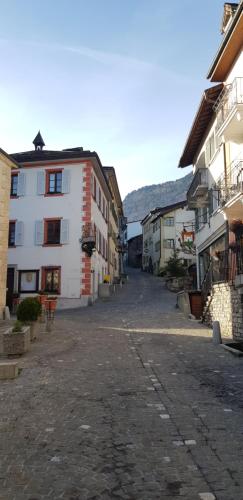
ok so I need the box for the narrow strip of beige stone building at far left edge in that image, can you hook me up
[0,158,11,318]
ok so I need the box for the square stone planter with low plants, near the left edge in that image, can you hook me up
[3,321,30,356]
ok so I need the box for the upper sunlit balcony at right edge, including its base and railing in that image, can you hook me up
[214,78,243,140]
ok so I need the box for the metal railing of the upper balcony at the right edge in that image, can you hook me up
[214,77,243,132]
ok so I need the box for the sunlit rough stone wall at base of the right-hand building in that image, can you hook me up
[205,283,243,340]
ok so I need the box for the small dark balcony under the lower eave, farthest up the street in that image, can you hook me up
[187,168,208,209]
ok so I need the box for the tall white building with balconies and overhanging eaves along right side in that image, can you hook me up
[179,1,243,337]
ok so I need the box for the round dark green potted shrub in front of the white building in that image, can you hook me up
[17,297,41,340]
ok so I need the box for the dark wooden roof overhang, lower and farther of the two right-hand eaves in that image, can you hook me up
[178,83,223,168]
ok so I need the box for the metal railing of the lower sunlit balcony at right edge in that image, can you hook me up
[217,159,243,206]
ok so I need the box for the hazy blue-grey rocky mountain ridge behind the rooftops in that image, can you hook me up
[123,172,192,222]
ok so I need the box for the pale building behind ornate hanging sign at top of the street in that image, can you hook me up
[142,201,195,275]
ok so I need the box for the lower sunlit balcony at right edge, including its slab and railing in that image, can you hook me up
[217,159,243,221]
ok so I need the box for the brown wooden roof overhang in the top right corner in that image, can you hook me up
[207,0,243,82]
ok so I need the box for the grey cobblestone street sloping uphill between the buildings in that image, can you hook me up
[0,272,243,500]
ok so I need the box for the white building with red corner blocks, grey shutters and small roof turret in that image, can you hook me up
[8,134,111,307]
